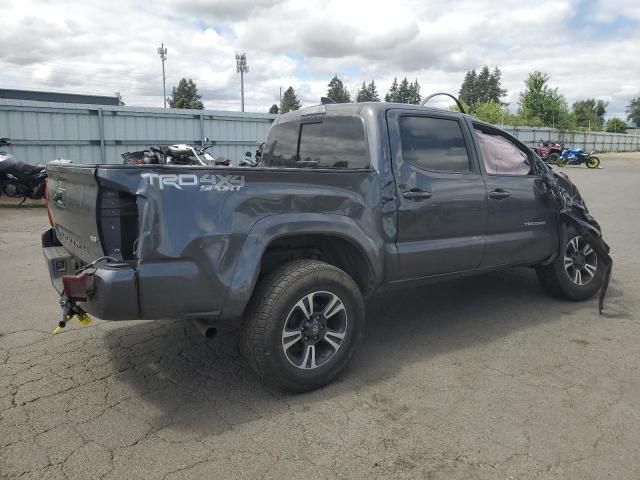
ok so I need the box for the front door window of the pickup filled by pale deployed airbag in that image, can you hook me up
[474,128,531,175]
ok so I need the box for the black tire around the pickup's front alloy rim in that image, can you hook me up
[536,226,605,301]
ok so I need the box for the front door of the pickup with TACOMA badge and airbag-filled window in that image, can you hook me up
[473,123,558,267]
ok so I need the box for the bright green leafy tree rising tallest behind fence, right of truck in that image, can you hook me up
[518,71,575,130]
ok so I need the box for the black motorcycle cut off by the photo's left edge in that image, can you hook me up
[0,138,47,205]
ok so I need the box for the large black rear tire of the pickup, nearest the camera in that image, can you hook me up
[240,260,364,392]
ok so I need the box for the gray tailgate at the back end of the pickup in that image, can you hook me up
[47,164,104,262]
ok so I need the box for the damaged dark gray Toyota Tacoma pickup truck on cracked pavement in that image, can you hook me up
[42,103,609,391]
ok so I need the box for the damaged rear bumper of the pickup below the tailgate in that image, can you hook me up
[42,229,140,320]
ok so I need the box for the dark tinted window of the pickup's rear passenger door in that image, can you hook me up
[399,116,471,173]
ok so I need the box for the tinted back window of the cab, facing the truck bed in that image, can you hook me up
[263,117,369,169]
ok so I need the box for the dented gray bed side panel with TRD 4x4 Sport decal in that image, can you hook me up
[99,166,384,319]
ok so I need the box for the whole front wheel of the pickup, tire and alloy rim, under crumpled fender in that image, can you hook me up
[536,227,604,300]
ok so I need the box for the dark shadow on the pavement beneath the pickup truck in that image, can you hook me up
[102,269,596,438]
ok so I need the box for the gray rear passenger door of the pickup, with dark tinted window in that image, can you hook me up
[387,110,487,281]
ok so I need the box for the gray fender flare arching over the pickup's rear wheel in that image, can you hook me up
[223,213,384,318]
